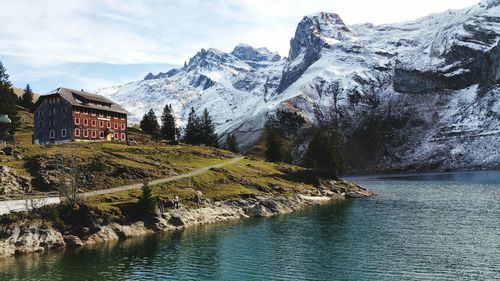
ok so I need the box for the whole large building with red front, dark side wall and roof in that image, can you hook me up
[33,88,128,144]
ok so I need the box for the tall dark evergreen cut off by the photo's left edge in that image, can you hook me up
[0,61,19,134]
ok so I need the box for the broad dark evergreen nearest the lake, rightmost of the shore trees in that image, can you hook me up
[304,128,345,178]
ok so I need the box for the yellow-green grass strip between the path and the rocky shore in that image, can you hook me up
[87,156,314,213]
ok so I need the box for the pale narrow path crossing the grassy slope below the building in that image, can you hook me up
[0,156,244,215]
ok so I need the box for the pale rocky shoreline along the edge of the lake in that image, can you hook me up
[0,180,374,257]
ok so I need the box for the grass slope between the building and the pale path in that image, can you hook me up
[0,111,235,190]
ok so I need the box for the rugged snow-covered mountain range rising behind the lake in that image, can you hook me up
[98,0,500,171]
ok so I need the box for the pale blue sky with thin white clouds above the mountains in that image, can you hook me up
[0,0,479,93]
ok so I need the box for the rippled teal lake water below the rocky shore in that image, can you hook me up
[0,172,500,280]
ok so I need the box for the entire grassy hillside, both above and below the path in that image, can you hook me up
[0,108,318,202]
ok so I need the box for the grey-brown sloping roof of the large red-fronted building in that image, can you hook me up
[34,87,129,114]
